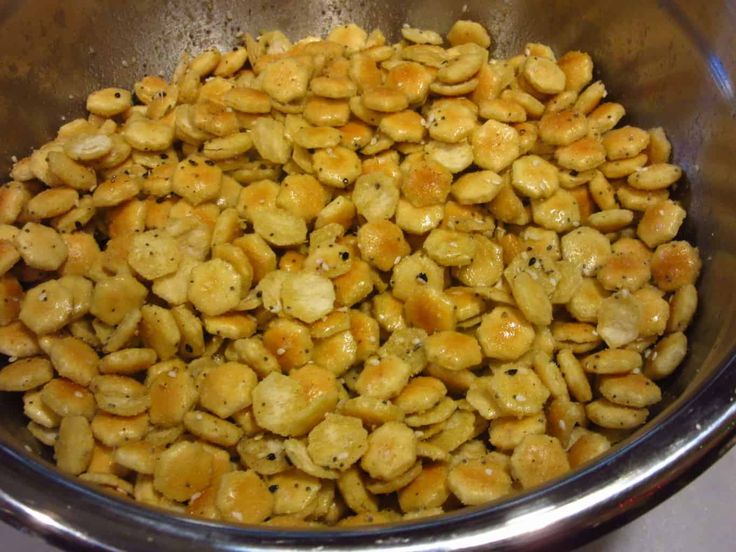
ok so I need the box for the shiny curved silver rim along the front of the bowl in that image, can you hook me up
[0,352,736,551]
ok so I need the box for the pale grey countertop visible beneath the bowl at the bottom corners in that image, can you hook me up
[0,448,736,552]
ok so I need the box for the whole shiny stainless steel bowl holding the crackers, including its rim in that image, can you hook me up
[0,0,736,551]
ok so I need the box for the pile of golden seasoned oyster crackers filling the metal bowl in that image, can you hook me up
[0,17,701,527]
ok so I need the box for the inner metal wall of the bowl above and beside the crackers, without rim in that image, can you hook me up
[0,0,736,532]
